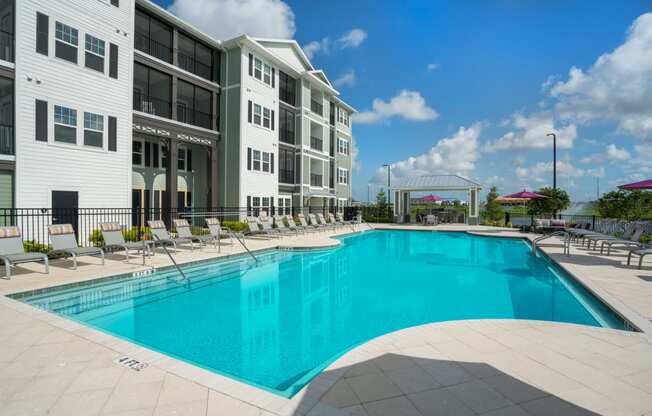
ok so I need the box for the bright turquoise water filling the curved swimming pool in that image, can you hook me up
[15,231,625,396]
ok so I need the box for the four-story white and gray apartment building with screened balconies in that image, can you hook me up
[0,0,355,219]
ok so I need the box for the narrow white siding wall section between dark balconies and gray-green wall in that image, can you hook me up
[240,48,279,207]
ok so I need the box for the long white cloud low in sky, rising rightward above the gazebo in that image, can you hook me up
[372,123,482,183]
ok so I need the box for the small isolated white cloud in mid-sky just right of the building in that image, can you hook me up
[354,90,439,124]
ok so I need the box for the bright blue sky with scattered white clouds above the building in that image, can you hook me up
[155,0,652,201]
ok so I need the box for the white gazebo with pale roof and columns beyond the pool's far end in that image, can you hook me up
[390,175,482,225]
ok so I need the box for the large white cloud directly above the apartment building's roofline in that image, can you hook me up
[168,0,296,40]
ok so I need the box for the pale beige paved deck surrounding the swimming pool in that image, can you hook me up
[0,224,652,416]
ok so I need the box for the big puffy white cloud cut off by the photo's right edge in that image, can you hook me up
[550,13,652,141]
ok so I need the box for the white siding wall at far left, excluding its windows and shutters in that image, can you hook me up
[16,0,134,208]
